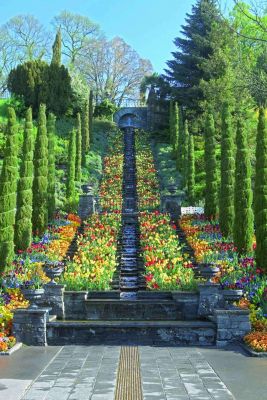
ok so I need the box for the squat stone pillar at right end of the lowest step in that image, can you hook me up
[217,307,251,347]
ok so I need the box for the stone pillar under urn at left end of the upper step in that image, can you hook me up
[44,283,65,319]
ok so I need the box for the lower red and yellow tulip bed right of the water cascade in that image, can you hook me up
[139,211,196,290]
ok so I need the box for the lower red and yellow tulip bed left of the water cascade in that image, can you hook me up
[61,212,121,291]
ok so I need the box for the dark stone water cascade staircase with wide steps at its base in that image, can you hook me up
[47,128,216,345]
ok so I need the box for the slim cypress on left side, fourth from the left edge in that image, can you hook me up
[47,113,56,221]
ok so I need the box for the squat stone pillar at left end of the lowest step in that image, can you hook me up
[13,308,50,346]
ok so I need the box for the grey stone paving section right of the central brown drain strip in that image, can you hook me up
[139,347,234,400]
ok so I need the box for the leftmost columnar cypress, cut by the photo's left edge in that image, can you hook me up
[0,108,18,271]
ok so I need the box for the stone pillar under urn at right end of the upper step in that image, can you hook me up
[198,282,223,317]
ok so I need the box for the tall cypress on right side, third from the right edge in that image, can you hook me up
[219,103,235,237]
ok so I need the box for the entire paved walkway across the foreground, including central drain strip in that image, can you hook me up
[0,346,267,400]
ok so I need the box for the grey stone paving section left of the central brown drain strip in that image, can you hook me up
[22,346,120,400]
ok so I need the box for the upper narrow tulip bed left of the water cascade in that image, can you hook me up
[99,133,123,211]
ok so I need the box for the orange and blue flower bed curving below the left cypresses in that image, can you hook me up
[0,214,80,351]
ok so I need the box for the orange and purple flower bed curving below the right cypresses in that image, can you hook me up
[180,215,267,351]
